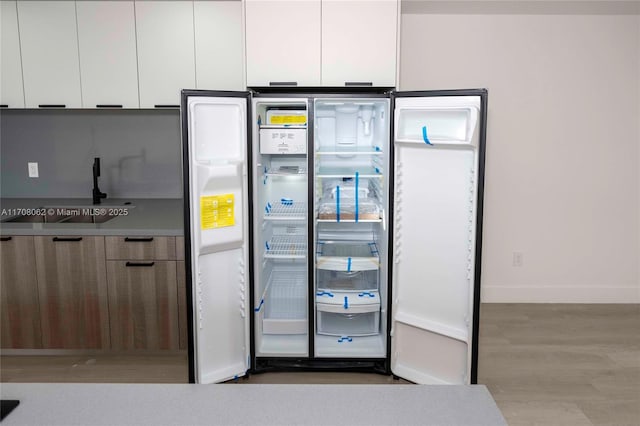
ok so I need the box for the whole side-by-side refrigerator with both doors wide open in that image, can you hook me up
[181,88,487,384]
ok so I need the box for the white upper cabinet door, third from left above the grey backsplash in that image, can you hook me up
[76,0,139,108]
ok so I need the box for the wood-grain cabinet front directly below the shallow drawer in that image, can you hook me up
[107,260,179,350]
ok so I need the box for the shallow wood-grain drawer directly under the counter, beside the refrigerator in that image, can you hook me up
[105,236,176,260]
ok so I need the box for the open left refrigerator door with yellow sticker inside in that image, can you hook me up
[182,91,250,383]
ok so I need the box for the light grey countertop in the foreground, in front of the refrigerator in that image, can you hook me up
[1,383,506,426]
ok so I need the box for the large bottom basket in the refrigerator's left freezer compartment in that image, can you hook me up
[257,266,308,334]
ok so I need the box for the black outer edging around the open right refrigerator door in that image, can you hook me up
[387,89,488,384]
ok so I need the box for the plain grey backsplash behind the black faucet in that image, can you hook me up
[0,110,182,198]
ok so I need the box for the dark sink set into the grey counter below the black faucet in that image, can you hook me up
[2,205,135,223]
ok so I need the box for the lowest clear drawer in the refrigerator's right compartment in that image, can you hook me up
[317,309,380,336]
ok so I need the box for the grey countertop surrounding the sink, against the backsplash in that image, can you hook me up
[0,198,184,236]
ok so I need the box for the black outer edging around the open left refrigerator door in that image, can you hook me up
[180,89,255,383]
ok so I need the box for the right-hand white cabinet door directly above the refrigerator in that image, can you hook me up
[322,0,398,87]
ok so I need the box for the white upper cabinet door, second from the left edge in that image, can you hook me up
[18,1,82,108]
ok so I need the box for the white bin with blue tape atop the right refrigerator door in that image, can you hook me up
[396,107,478,144]
